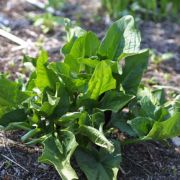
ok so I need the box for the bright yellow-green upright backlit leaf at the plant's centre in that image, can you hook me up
[86,61,116,99]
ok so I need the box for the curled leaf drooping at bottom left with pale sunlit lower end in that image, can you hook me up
[39,130,78,180]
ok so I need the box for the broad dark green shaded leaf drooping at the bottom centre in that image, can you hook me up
[75,142,121,180]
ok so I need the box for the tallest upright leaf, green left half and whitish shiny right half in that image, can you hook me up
[98,15,141,61]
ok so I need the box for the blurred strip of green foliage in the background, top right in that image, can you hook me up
[101,0,180,20]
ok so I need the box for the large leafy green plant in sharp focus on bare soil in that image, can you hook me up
[0,16,180,180]
